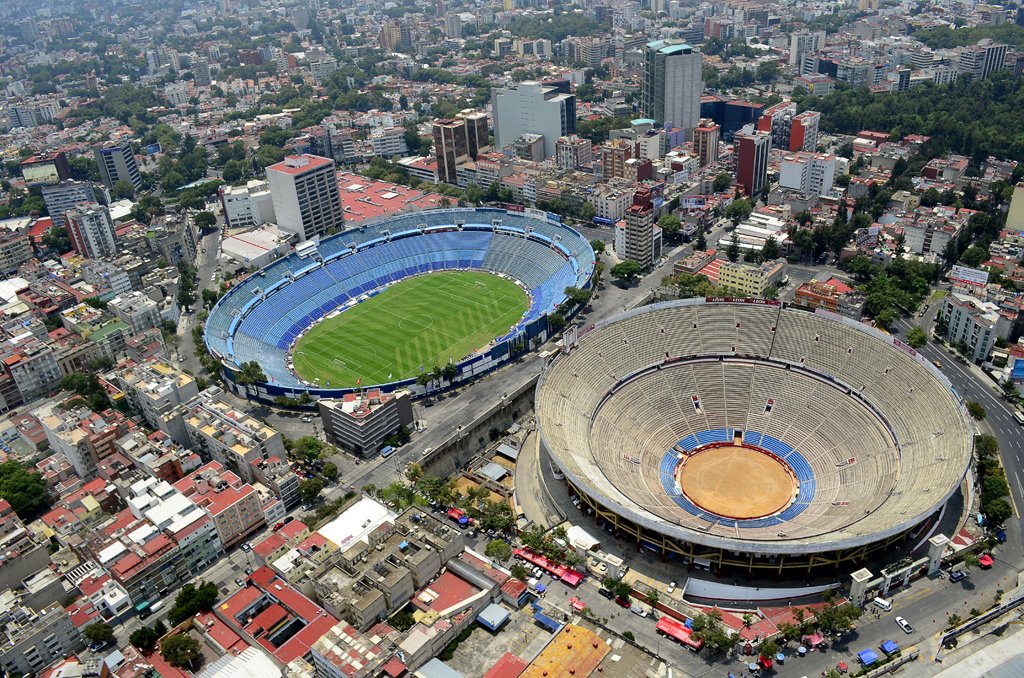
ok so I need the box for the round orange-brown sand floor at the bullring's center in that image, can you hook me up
[676,443,798,520]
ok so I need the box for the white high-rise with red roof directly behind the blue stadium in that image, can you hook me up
[266,155,345,242]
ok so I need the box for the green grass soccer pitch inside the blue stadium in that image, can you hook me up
[292,271,529,388]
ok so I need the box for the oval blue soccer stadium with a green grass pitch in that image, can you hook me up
[205,209,594,399]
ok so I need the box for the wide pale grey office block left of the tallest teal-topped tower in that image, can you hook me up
[490,80,575,158]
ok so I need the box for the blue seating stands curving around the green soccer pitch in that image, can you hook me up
[206,209,594,386]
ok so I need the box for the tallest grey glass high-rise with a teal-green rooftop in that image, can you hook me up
[643,40,703,138]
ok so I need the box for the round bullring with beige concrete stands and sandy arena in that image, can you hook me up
[536,299,973,573]
